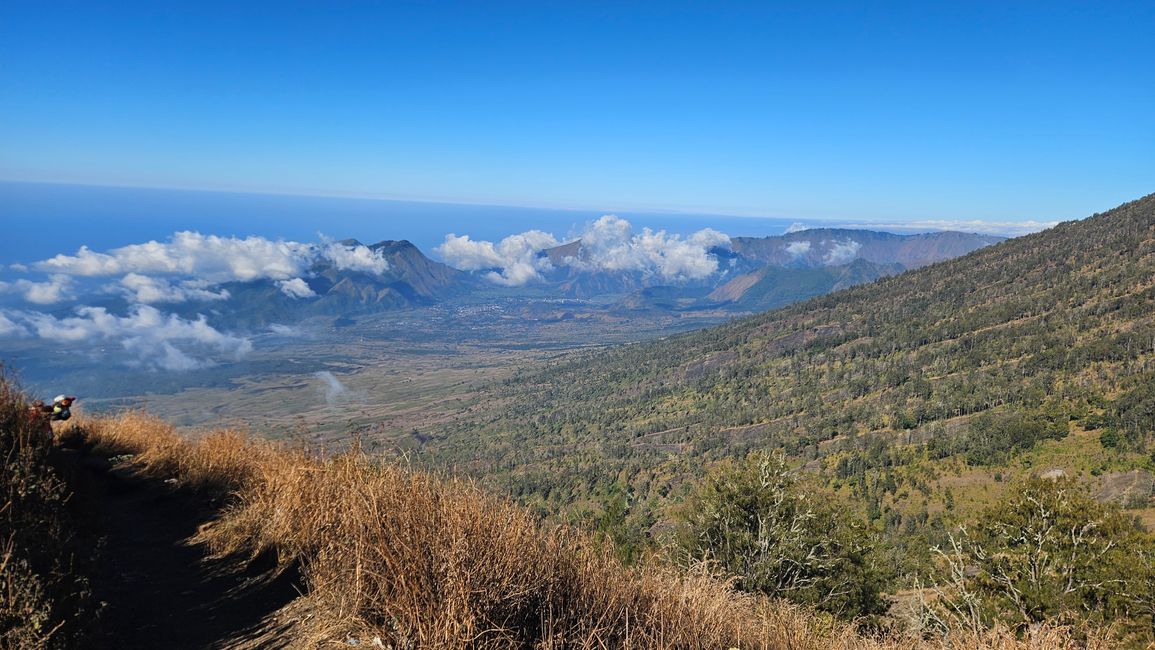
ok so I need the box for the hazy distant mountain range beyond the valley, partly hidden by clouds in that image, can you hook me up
[174,229,1001,327]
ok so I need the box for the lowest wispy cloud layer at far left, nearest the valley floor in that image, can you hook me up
[0,305,252,371]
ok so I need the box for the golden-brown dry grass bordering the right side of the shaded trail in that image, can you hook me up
[76,414,1106,650]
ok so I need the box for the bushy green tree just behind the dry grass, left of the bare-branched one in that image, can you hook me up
[681,451,886,618]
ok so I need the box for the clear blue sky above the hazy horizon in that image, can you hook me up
[0,0,1155,221]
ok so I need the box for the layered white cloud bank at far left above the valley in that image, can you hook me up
[0,231,389,371]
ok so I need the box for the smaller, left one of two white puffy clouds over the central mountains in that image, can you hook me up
[434,230,559,286]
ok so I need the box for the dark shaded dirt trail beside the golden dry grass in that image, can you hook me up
[60,450,298,650]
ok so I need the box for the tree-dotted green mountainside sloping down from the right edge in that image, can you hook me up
[422,195,1155,571]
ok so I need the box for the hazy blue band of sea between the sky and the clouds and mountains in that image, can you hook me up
[0,181,1057,266]
